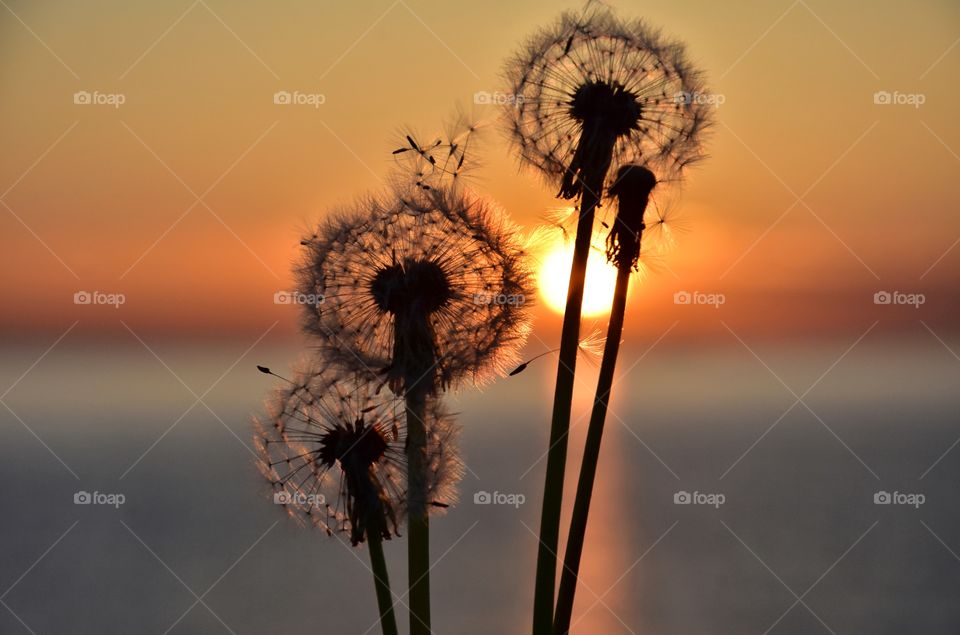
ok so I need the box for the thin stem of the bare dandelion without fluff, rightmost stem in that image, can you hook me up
[553,262,631,635]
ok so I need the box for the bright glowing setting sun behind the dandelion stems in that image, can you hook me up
[537,240,617,317]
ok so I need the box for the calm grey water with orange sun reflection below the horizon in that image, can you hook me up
[0,336,960,635]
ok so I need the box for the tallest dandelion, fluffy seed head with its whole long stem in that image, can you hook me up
[506,4,710,633]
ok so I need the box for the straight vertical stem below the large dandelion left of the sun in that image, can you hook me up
[406,389,431,635]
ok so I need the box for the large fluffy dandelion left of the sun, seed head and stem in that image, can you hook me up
[299,181,532,635]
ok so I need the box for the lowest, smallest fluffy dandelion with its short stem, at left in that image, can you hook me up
[254,367,462,633]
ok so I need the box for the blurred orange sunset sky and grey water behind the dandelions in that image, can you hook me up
[0,0,960,635]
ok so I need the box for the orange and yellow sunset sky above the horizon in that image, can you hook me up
[0,0,960,339]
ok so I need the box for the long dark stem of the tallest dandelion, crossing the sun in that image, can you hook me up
[533,181,603,635]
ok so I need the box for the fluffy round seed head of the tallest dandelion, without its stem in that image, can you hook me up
[506,3,711,198]
